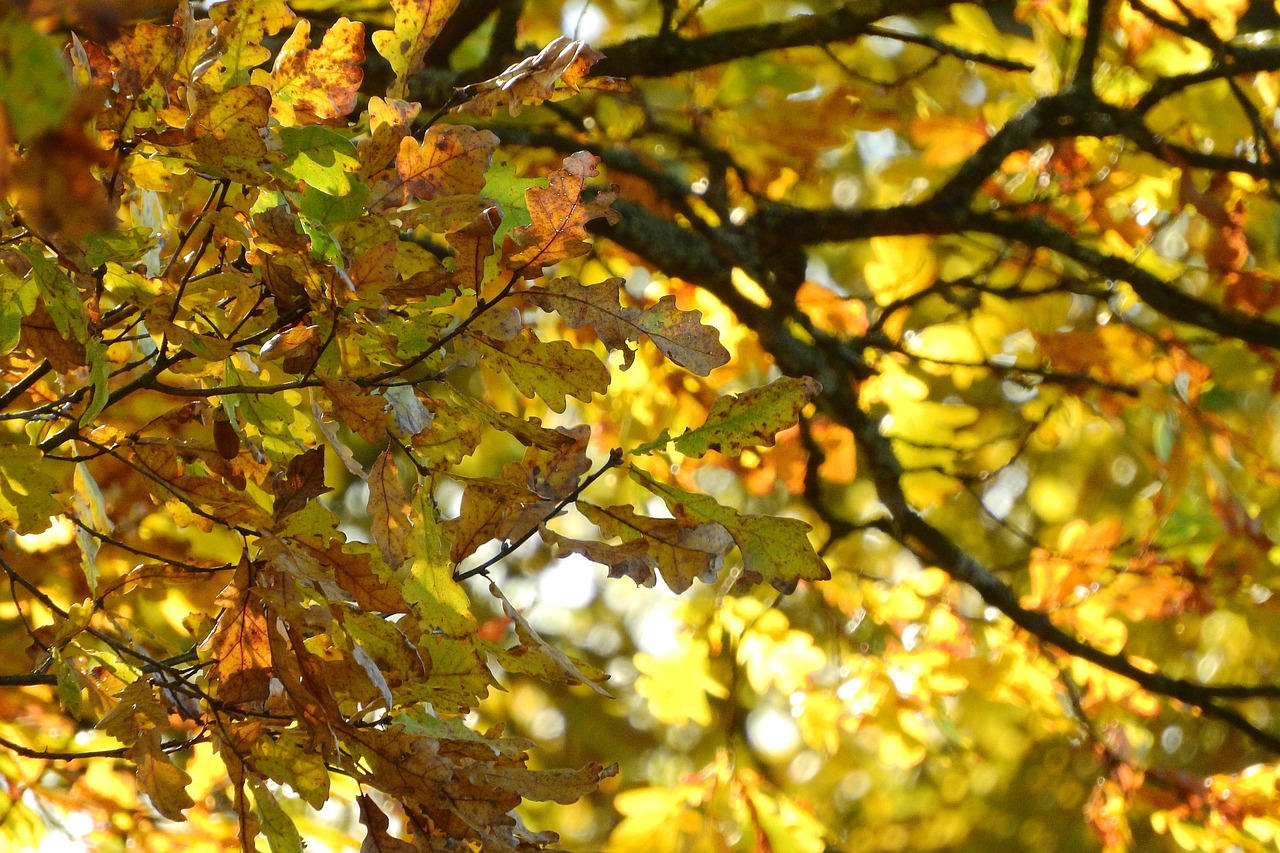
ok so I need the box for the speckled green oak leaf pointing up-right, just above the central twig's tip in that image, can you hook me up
[631,377,822,457]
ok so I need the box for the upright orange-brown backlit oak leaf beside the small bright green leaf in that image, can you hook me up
[502,151,618,278]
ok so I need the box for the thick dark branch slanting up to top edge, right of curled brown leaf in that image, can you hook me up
[591,0,952,78]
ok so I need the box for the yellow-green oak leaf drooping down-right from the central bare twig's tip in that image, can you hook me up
[631,467,831,593]
